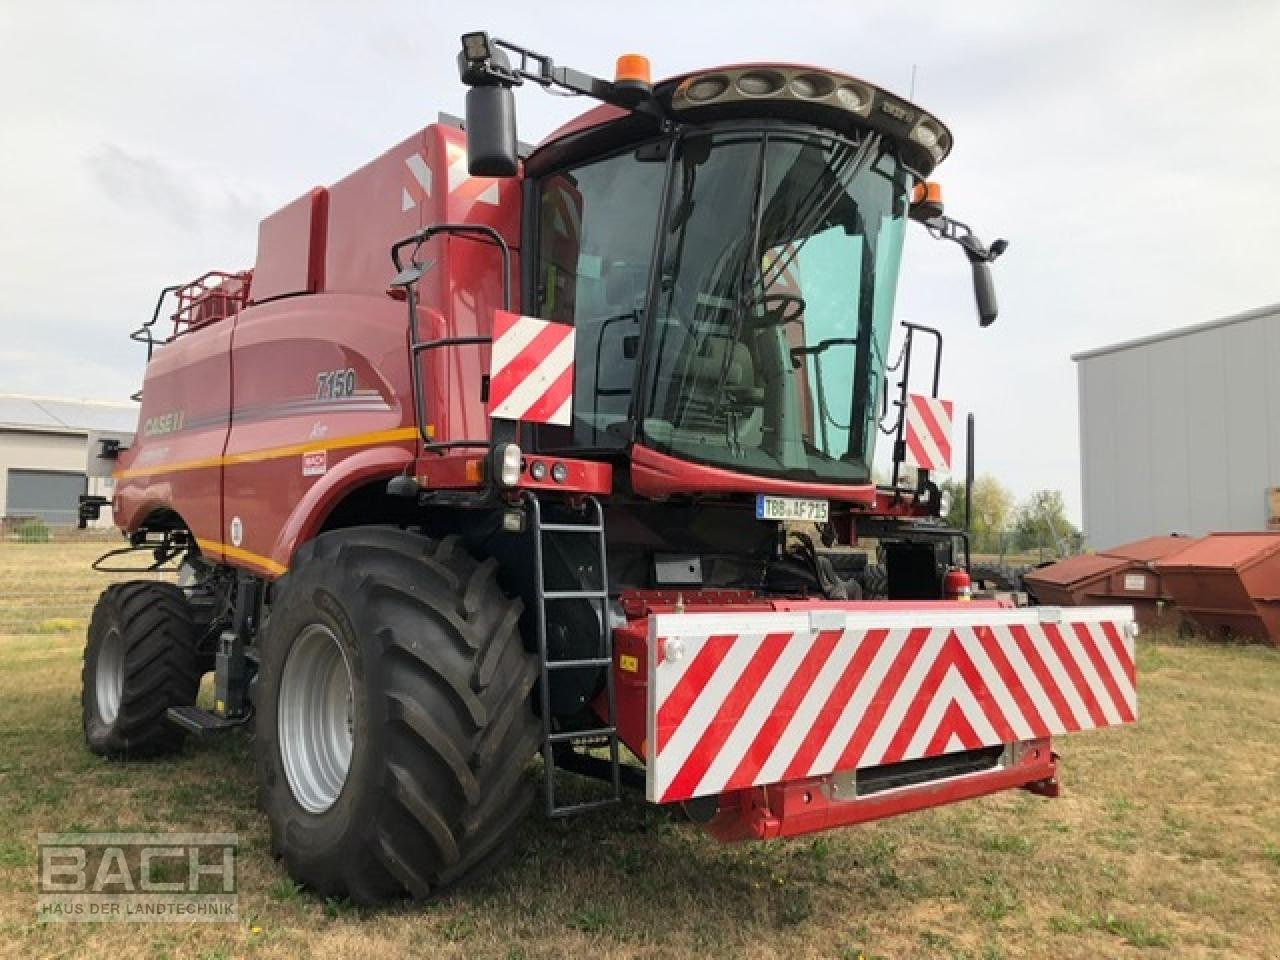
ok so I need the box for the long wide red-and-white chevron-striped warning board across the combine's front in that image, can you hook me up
[648,607,1138,803]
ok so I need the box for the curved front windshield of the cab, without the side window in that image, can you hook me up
[639,132,906,484]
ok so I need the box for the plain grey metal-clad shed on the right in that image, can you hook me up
[1071,303,1280,549]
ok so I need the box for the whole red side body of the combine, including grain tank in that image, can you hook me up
[114,124,522,576]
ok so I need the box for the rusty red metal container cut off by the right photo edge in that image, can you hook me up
[1156,532,1280,645]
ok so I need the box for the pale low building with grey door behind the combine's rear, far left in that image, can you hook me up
[0,394,138,526]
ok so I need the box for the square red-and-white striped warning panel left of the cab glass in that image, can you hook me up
[489,310,573,426]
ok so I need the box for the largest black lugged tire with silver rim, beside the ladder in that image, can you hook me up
[255,527,540,904]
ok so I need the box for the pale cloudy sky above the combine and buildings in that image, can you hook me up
[0,0,1280,520]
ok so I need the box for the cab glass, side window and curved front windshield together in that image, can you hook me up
[534,127,909,484]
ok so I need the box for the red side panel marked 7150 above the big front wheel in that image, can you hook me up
[220,294,415,576]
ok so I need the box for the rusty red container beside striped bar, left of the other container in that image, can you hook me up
[1023,536,1197,626]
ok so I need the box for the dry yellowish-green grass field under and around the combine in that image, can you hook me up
[0,544,1280,960]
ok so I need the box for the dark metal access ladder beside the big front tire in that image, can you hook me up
[524,490,622,817]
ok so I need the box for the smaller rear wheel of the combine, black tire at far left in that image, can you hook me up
[81,580,206,759]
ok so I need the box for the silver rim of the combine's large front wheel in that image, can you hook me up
[278,623,355,813]
